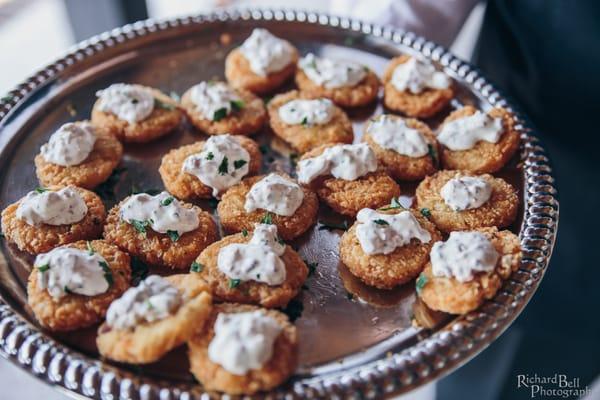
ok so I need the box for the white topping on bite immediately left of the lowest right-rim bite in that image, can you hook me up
[356,208,431,254]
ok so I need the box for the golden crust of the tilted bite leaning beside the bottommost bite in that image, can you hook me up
[96,275,212,364]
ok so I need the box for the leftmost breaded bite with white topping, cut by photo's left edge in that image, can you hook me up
[2,186,106,254]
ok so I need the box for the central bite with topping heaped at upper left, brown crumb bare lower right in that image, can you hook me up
[297,143,400,217]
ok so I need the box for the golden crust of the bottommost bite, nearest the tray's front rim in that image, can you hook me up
[188,304,298,395]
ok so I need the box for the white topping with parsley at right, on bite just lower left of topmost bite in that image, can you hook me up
[190,82,243,121]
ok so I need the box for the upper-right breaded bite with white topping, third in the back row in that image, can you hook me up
[383,55,454,118]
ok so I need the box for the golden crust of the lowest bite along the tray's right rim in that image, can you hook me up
[417,228,521,314]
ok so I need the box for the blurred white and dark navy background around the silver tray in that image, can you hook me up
[0,0,600,400]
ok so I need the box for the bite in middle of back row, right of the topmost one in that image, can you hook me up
[296,53,380,107]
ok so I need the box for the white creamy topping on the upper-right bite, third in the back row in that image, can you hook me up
[391,57,450,94]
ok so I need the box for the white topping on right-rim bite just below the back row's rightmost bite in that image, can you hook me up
[437,111,504,150]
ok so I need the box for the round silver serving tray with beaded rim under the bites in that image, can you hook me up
[0,10,558,399]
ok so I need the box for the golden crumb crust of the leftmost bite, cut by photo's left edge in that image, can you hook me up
[2,186,106,254]
